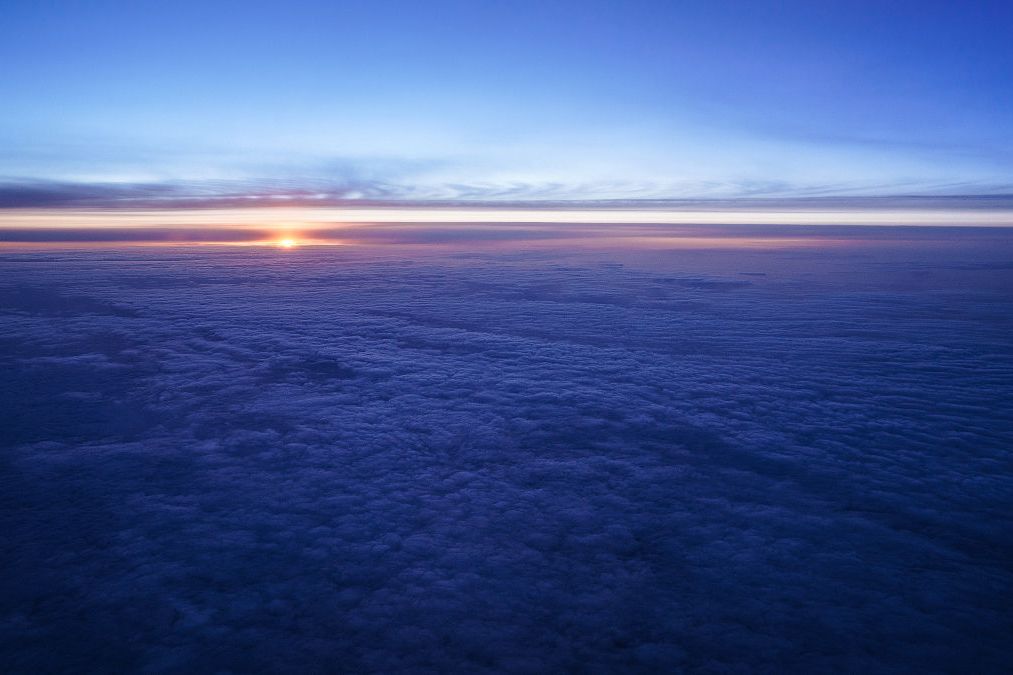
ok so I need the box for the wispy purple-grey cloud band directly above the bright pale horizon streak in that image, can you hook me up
[0,175,1013,210]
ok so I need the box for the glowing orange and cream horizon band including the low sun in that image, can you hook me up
[0,208,1013,251]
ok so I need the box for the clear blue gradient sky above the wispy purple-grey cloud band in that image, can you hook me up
[0,0,1013,206]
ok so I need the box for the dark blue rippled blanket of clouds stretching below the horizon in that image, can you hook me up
[0,231,1013,673]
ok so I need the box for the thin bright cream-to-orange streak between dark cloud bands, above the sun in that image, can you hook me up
[0,205,1013,242]
